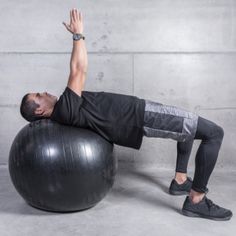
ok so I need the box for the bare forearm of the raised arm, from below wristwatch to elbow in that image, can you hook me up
[70,39,88,72]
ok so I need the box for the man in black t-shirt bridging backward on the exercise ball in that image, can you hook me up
[20,9,232,220]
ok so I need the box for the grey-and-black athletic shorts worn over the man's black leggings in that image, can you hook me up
[143,100,198,142]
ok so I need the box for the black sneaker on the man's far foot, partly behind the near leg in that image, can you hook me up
[169,177,193,195]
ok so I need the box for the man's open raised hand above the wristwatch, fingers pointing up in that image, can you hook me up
[63,8,84,34]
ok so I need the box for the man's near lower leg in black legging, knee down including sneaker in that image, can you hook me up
[182,119,232,220]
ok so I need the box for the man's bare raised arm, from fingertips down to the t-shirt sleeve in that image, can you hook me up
[63,9,88,96]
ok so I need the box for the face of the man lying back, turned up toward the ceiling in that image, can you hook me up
[28,92,57,115]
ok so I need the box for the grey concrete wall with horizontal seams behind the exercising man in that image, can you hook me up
[0,0,236,169]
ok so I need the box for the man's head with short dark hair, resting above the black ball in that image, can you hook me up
[20,92,57,122]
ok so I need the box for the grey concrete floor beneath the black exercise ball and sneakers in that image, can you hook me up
[0,164,236,236]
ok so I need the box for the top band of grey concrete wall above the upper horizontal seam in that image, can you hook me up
[0,0,236,52]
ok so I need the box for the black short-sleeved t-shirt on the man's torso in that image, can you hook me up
[50,87,145,149]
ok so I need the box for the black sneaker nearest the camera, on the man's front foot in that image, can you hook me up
[182,196,233,220]
